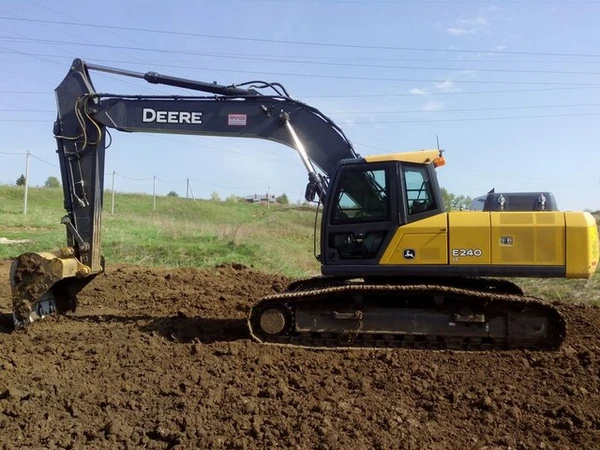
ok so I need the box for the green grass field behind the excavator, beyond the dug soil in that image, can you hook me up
[0,186,600,305]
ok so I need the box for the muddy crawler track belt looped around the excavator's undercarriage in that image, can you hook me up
[248,277,566,350]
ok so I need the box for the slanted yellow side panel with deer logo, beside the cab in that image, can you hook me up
[380,214,448,265]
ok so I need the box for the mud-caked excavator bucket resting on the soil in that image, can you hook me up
[10,247,97,329]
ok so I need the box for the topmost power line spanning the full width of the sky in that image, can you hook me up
[0,16,600,58]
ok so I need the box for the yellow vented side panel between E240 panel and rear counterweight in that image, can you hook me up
[489,211,565,266]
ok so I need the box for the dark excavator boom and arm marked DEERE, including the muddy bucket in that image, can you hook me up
[10,59,358,328]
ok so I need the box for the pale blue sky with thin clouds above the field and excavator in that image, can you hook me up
[0,0,600,210]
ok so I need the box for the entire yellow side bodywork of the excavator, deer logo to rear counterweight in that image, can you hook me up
[379,211,599,278]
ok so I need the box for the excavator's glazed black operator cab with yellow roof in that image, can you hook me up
[320,150,444,268]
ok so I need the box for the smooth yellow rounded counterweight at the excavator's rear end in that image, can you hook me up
[565,212,598,278]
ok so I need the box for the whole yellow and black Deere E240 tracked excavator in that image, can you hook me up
[10,59,598,350]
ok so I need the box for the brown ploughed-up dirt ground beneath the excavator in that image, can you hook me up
[0,261,600,450]
